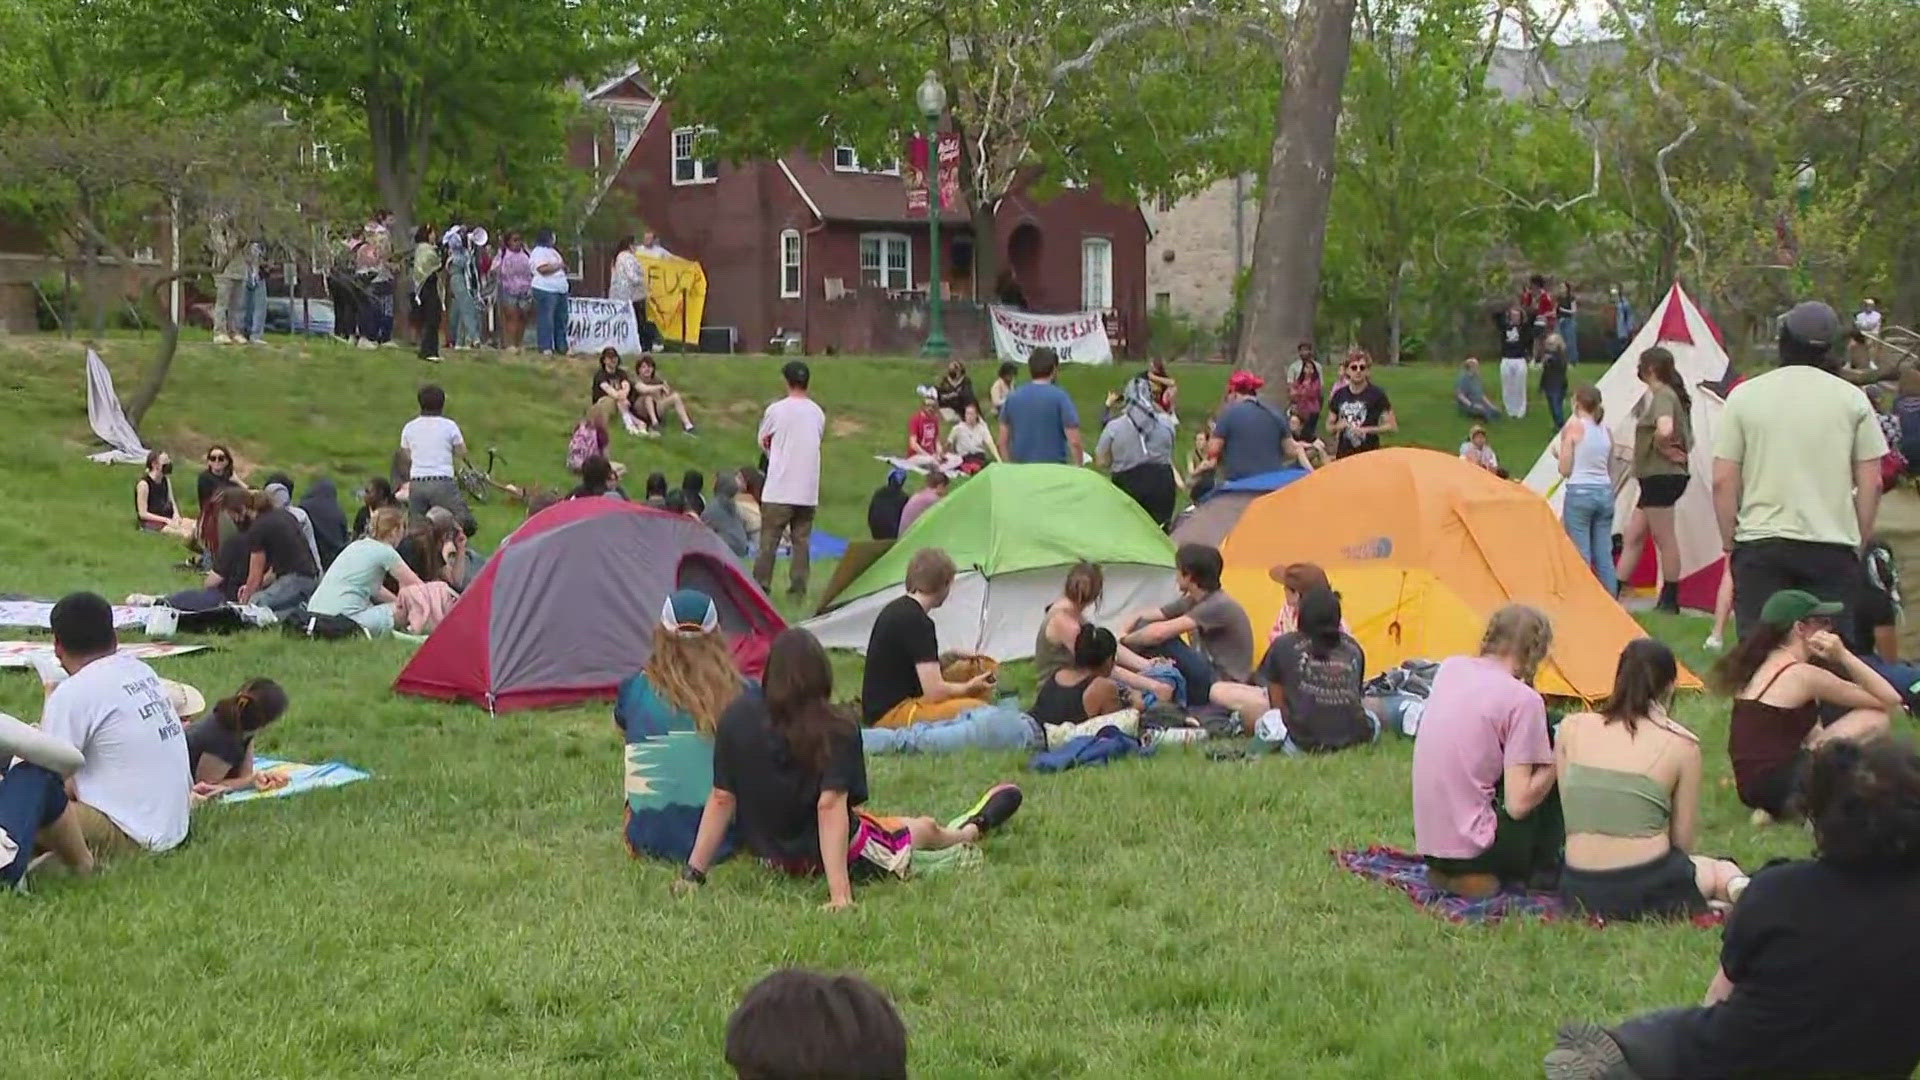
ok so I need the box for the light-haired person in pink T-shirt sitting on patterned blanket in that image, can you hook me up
[1413,603,1565,897]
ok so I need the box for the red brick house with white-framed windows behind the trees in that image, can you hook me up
[572,73,1148,356]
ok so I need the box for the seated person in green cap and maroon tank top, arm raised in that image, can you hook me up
[1713,588,1901,824]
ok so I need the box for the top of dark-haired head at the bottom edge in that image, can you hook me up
[726,967,906,1080]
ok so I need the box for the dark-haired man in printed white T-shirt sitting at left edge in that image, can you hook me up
[0,592,192,886]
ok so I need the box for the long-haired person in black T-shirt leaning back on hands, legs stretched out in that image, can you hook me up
[674,628,1021,909]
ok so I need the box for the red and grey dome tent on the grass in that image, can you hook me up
[394,498,785,711]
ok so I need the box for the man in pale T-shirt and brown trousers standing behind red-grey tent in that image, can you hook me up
[753,359,828,598]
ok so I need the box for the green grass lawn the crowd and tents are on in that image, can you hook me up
[0,338,1835,1078]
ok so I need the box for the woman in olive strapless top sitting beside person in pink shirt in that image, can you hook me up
[1553,638,1747,919]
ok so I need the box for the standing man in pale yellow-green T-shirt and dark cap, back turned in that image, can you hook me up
[1713,302,1887,650]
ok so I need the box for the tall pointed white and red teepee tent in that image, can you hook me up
[1526,284,1728,611]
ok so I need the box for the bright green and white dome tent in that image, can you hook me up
[804,465,1173,661]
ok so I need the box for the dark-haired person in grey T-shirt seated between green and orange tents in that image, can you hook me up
[1119,544,1265,715]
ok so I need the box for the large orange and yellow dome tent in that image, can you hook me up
[1221,448,1699,701]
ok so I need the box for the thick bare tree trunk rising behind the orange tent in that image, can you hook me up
[1238,0,1356,386]
